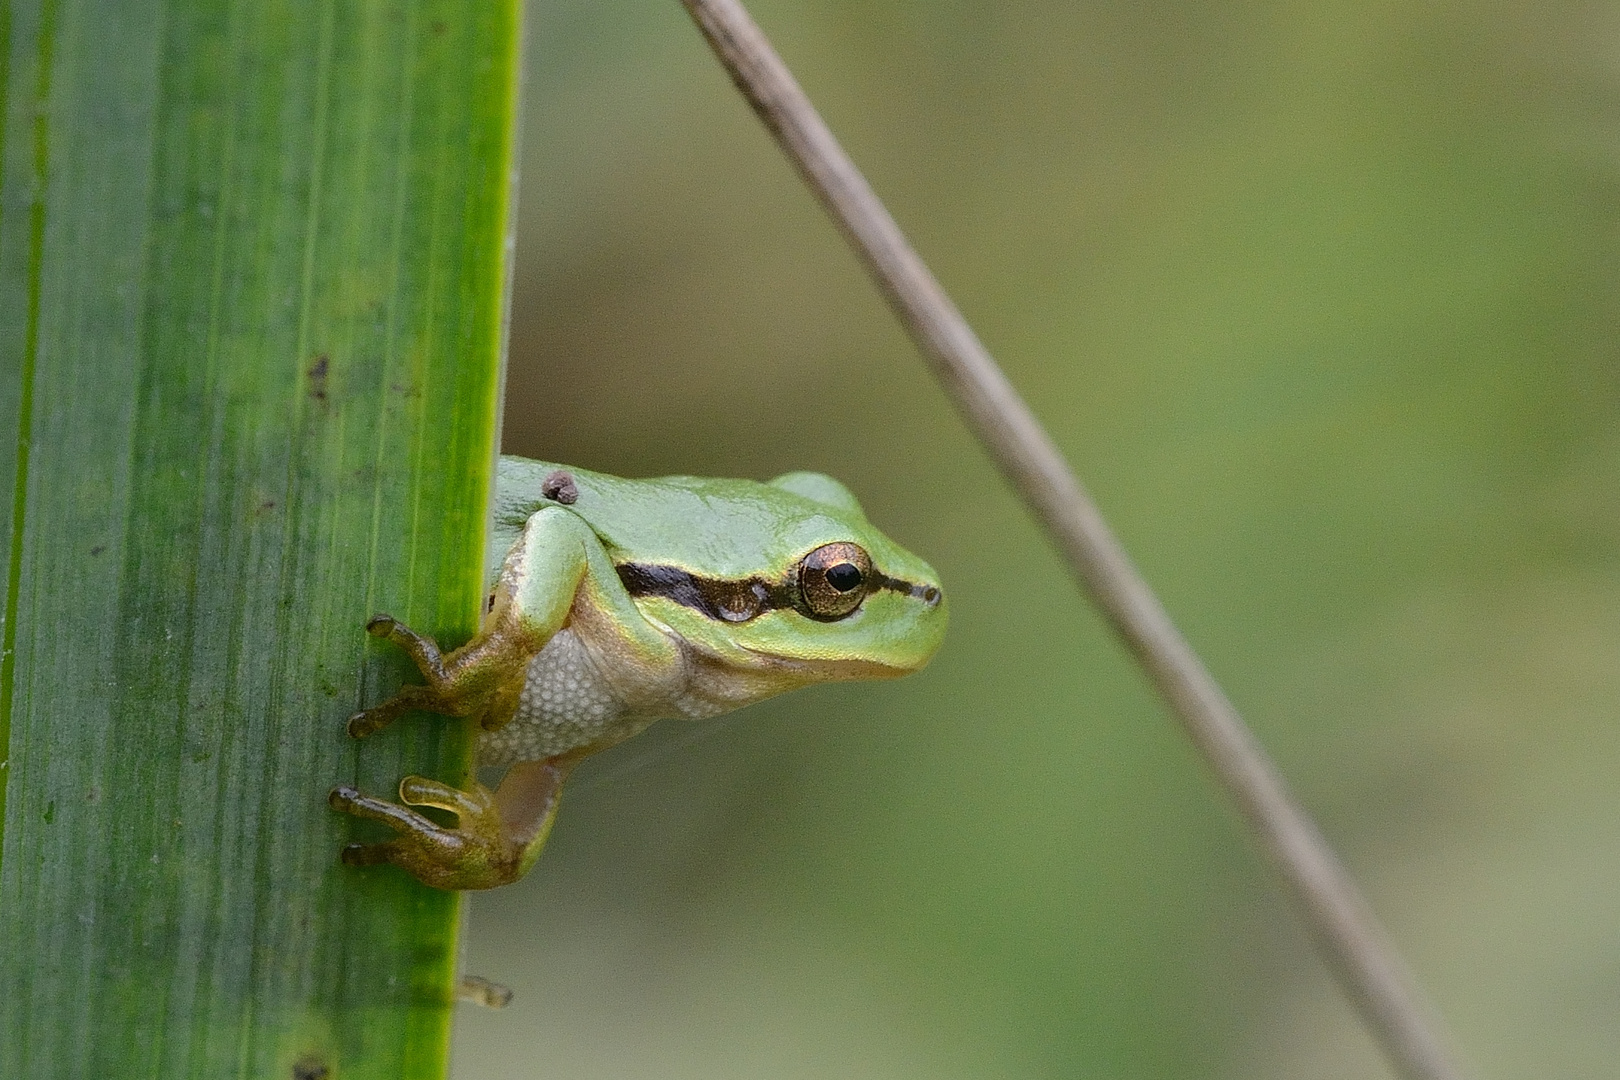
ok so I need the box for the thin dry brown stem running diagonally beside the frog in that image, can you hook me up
[682,0,1466,1080]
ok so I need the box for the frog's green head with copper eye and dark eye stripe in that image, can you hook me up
[619,473,948,693]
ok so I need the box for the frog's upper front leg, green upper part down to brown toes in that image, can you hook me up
[348,507,606,738]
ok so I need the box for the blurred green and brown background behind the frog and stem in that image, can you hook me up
[455,0,1620,1080]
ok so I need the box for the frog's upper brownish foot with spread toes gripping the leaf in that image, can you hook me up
[348,615,523,738]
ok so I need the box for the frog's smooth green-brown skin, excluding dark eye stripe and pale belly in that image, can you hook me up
[330,457,948,889]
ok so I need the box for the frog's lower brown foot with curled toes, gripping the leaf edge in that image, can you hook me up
[327,776,523,889]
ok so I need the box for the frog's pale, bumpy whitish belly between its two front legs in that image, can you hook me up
[478,628,656,766]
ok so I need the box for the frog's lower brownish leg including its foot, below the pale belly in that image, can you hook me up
[327,751,583,889]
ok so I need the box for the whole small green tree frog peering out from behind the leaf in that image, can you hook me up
[329,457,946,889]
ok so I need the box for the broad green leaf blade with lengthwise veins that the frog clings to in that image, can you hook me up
[0,0,517,1077]
